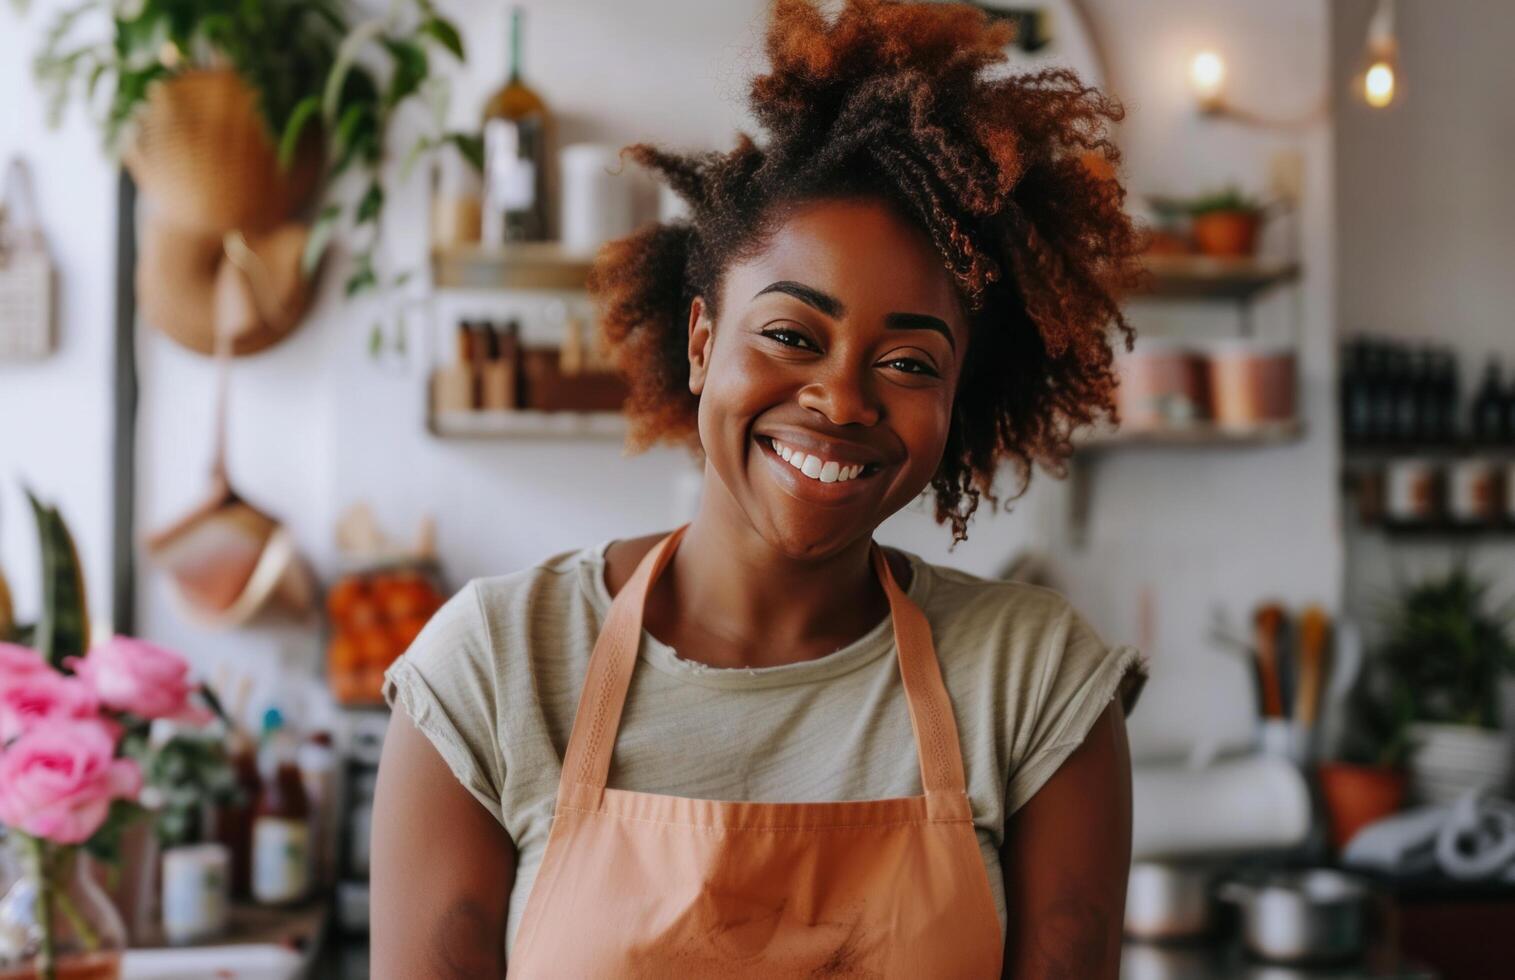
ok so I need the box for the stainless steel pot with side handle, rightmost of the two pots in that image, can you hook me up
[1218,868,1368,963]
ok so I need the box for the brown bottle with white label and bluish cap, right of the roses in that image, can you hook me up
[253,707,311,906]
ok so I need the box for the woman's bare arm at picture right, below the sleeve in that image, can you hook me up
[1000,701,1132,980]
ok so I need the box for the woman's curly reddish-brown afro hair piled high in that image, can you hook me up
[589,0,1141,544]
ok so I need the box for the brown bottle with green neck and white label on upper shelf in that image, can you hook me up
[482,8,551,245]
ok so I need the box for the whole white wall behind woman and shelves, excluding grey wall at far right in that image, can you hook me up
[0,0,1339,760]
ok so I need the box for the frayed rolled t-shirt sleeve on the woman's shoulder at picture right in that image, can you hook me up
[1004,606,1147,815]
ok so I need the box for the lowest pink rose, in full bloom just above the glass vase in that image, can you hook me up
[0,718,142,844]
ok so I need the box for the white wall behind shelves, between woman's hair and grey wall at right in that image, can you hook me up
[1059,0,1341,751]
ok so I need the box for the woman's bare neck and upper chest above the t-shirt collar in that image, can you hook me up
[644,472,907,666]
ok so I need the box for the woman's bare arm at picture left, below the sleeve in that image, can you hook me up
[370,710,515,980]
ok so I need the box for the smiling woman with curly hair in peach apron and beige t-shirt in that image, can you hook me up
[373,0,1145,978]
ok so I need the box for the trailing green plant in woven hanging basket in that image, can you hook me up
[33,0,483,295]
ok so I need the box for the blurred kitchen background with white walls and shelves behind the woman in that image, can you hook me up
[0,0,1515,977]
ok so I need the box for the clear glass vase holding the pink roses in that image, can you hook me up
[0,833,126,980]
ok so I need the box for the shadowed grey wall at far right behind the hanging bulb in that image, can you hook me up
[1332,0,1515,630]
